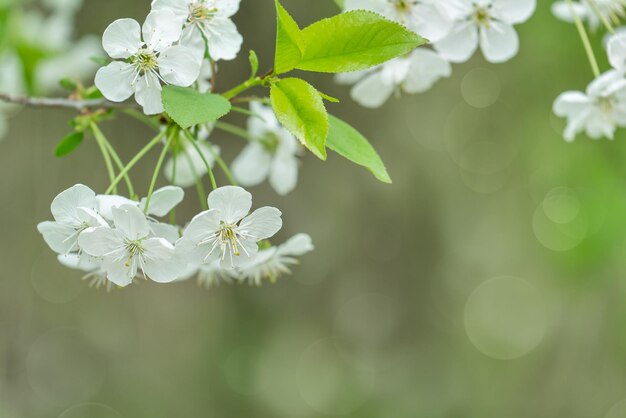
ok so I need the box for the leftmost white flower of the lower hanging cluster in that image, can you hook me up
[37,184,108,254]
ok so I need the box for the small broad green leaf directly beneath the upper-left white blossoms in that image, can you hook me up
[161,86,231,129]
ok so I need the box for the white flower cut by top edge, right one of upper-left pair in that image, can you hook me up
[152,0,243,61]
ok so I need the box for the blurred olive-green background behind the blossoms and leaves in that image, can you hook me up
[0,0,626,418]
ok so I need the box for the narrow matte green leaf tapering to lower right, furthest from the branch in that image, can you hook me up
[326,115,391,183]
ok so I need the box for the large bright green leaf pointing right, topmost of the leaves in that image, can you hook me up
[296,10,426,73]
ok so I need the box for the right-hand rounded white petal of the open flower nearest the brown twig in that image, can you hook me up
[158,45,200,87]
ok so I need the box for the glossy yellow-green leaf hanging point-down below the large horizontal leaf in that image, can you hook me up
[270,78,328,160]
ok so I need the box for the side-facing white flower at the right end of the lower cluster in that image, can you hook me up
[240,234,314,286]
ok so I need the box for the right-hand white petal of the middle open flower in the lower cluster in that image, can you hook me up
[143,238,184,283]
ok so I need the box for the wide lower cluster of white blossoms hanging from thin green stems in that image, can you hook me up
[38,184,313,287]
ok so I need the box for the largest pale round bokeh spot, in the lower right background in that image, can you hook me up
[465,277,548,360]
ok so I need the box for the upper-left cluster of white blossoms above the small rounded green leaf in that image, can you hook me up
[95,0,243,115]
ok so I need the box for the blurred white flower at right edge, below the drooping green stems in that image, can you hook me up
[553,70,626,141]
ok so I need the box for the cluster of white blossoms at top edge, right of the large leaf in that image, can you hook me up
[337,0,536,108]
